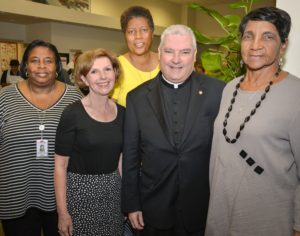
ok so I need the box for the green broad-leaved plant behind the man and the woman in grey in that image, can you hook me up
[190,0,259,82]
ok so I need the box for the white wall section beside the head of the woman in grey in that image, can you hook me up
[276,0,300,78]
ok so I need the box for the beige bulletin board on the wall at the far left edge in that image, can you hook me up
[0,42,18,72]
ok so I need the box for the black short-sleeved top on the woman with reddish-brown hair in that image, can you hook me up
[55,98,125,174]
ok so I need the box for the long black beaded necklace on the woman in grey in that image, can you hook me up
[223,68,281,143]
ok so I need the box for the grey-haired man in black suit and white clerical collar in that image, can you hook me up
[122,25,224,236]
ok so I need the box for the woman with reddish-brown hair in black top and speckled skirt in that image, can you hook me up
[55,49,124,236]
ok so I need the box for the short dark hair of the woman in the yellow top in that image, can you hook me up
[120,6,154,33]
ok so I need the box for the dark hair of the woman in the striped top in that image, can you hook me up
[20,39,62,79]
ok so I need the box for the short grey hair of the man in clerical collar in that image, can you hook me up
[158,25,197,49]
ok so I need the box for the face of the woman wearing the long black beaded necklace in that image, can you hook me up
[241,21,287,71]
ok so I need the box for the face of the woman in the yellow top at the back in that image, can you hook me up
[125,17,153,55]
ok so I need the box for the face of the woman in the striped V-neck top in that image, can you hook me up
[27,46,56,85]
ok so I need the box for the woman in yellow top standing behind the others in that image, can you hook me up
[112,6,159,107]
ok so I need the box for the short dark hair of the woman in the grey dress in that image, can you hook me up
[239,7,291,43]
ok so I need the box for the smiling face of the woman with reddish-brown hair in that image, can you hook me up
[81,57,116,96]
